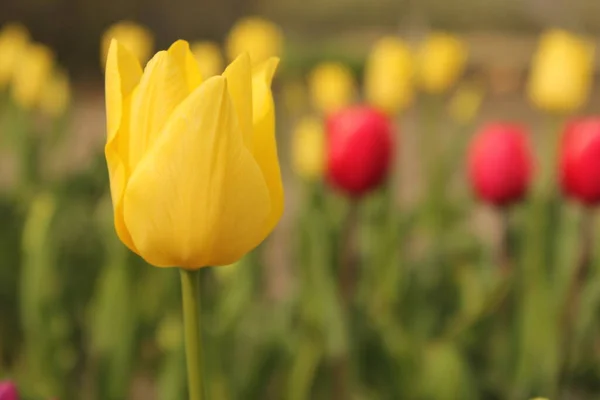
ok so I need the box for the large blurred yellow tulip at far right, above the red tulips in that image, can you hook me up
[527,30,594,113]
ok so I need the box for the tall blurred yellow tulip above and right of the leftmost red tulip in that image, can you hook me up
[365,37,414,114]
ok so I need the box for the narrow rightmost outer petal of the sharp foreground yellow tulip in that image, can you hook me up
[252,57,284,237]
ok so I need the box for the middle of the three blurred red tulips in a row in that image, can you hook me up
[468,123,533,206]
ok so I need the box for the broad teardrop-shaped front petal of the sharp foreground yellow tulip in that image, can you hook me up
[125,77,270,269]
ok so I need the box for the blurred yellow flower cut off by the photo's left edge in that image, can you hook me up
[0,23,29,89]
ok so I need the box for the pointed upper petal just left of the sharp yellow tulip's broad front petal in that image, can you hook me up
[129,51,189,171]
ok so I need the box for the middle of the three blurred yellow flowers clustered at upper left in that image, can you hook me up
[12,43,54,109]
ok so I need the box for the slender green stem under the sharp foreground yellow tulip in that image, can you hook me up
[179,268,204,400]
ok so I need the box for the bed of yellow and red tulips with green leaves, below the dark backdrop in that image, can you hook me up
[0,10,600,400]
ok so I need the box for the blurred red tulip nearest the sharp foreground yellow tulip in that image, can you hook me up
[327,106,394,197]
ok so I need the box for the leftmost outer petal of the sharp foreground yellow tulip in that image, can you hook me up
[104,40,142,252]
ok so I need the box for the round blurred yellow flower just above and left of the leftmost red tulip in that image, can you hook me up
[308,62,357,114]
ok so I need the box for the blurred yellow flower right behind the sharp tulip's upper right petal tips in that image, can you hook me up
[227,17,283,64]
